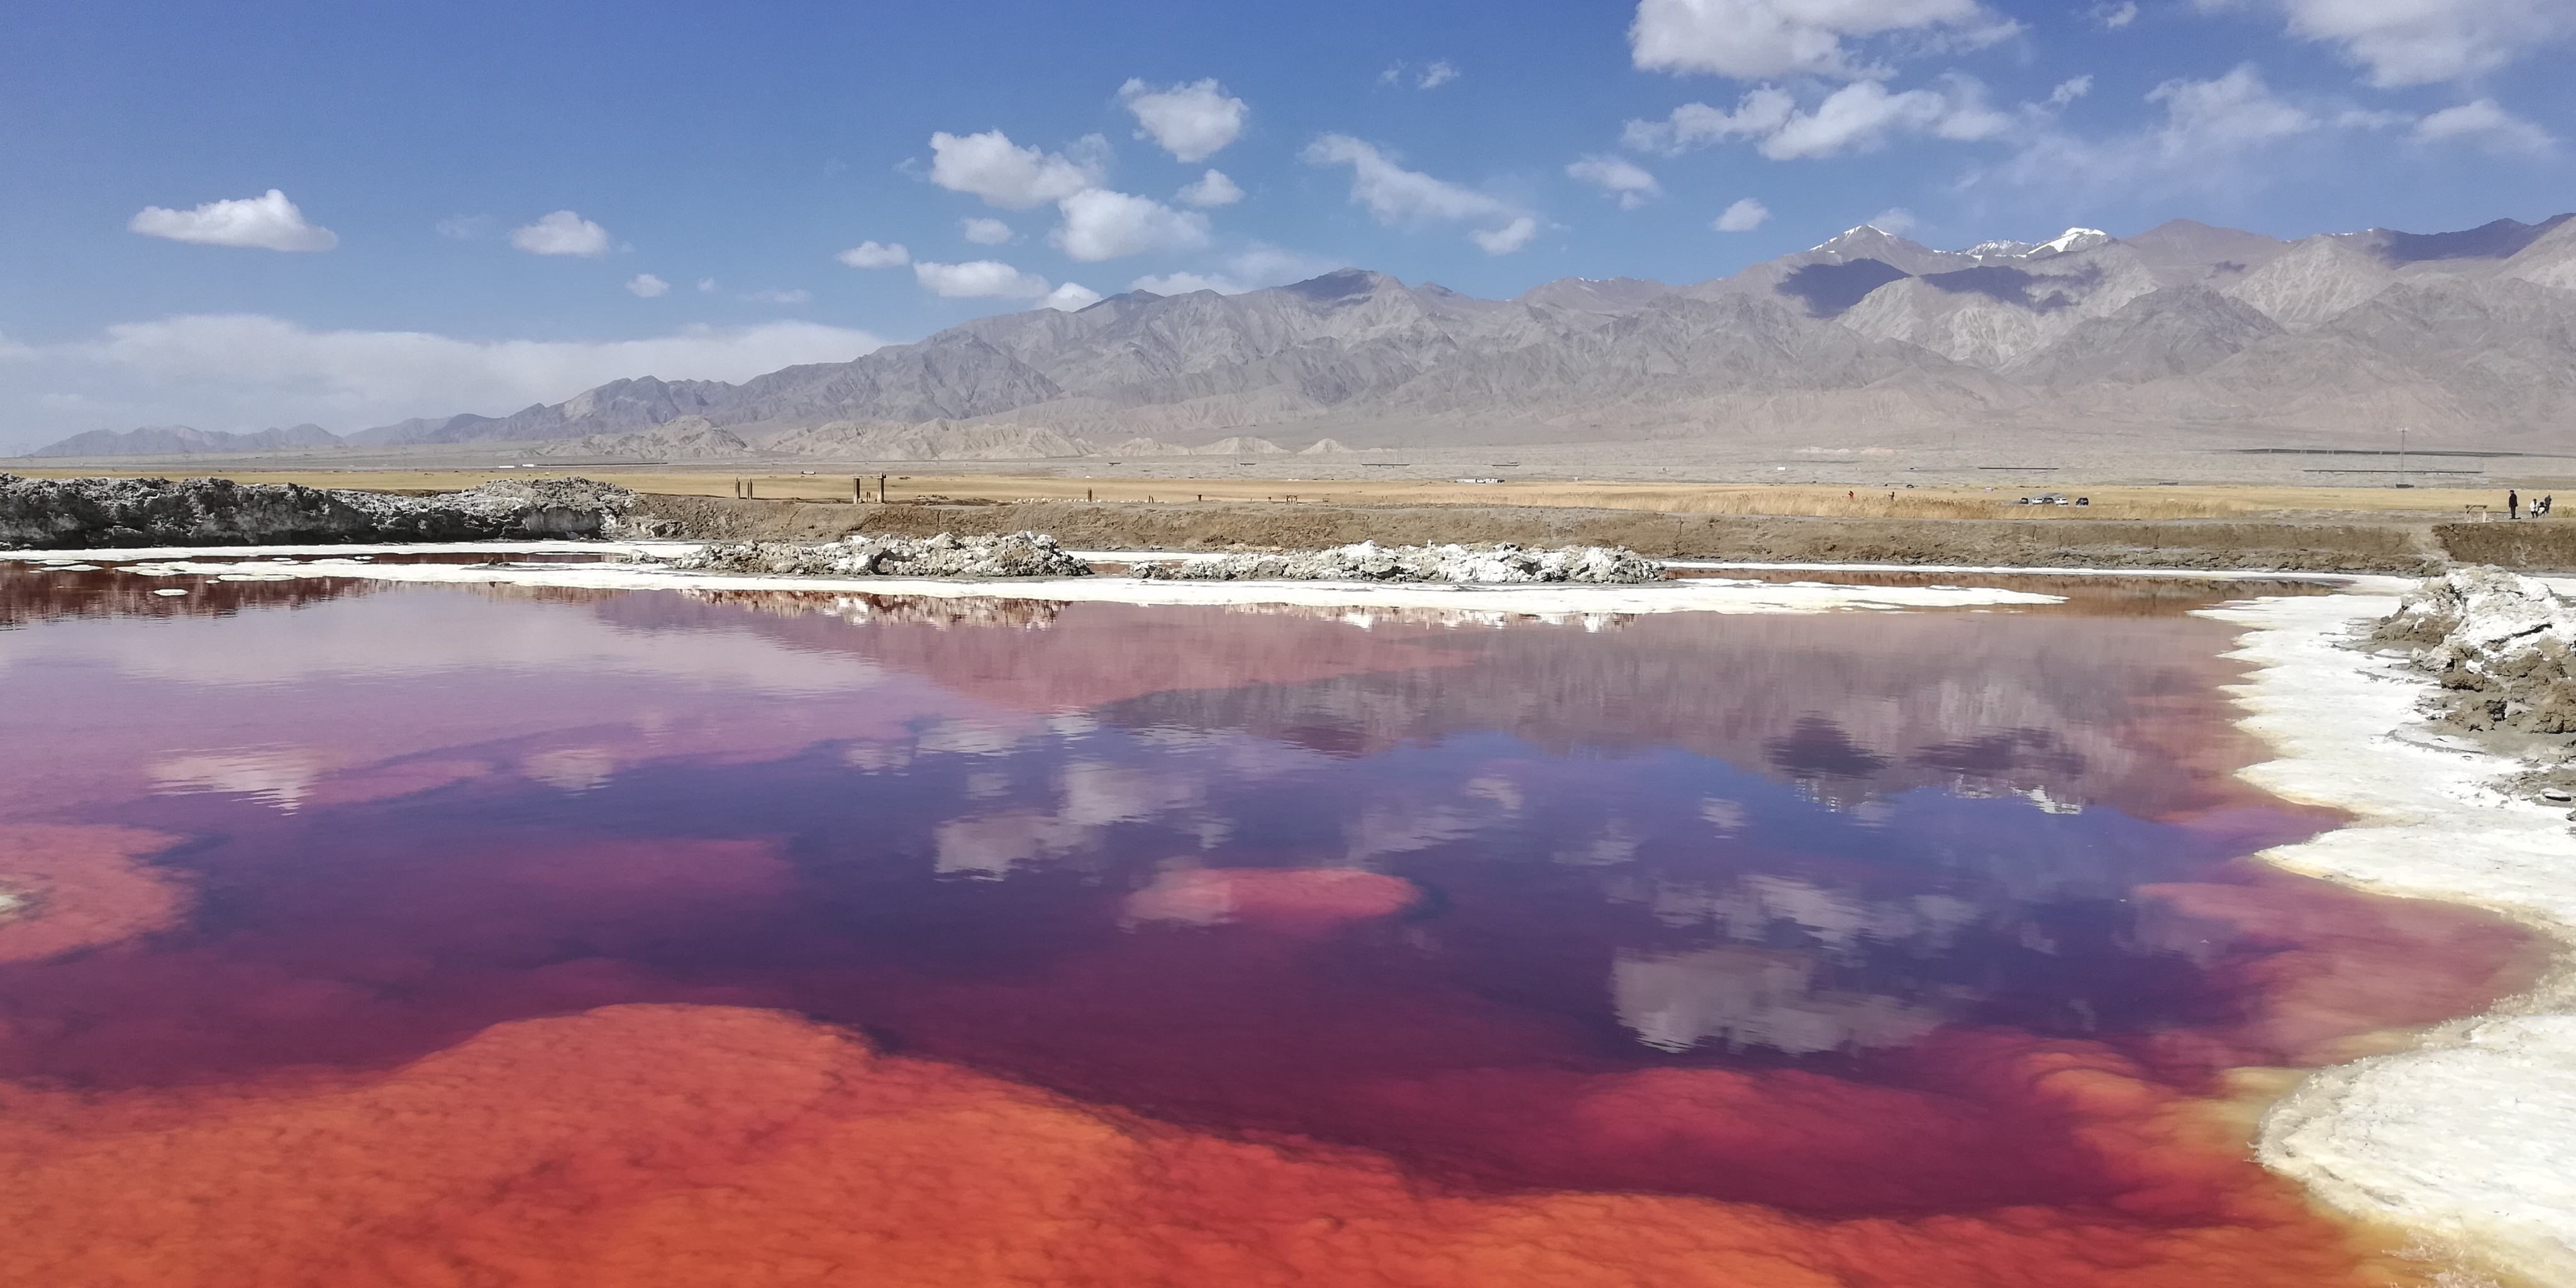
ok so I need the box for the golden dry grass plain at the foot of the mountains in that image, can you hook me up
[5,466,2576,520]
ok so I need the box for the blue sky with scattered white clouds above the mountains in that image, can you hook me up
[0,0,2576,446]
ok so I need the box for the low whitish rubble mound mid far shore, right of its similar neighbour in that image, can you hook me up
[1136,541,1672,585]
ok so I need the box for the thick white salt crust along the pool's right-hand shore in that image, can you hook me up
[2205,582,2576,1285]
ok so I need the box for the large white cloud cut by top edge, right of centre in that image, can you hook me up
[1628,0,2019,80]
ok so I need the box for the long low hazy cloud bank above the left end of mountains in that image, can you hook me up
[0,314,884,446]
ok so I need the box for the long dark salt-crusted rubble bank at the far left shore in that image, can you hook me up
[0,474,636,548]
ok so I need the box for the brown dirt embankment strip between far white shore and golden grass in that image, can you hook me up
[618,497,2576,572]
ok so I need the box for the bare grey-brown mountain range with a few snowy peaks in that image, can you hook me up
[25,214,2576,458]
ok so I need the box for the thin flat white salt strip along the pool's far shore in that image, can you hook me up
[0,541,2061,613]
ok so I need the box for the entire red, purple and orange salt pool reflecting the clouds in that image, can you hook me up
[0,569,2529,1288]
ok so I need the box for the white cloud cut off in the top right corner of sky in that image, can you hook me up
[2200,0,2576,87]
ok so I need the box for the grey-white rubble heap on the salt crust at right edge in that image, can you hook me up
[2372,567,2576,734]
